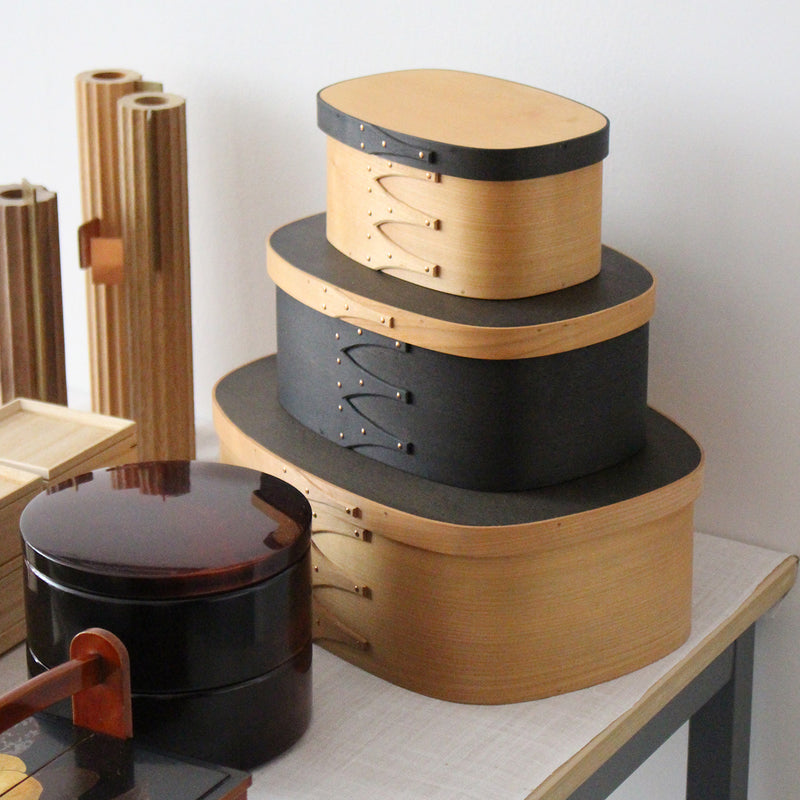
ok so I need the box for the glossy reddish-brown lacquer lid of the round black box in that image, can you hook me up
[20,461,311,598]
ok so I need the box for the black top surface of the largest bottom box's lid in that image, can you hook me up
[214,356,702,526]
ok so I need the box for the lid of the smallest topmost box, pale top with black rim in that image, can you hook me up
[317,69,608,180]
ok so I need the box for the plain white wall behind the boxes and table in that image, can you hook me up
[0,0,800,800]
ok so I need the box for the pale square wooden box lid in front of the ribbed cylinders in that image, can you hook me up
[0,398,136,481]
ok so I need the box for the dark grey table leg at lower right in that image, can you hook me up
[686,626,755,800]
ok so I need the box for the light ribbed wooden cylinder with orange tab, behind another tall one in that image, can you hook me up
[76,69,161,417]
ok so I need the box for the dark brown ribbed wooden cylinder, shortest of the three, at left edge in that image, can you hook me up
[0,181,67,403]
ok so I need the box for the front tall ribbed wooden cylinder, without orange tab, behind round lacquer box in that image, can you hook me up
[118,92,195,461]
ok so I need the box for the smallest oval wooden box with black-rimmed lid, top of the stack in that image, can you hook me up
[317,69,608,299]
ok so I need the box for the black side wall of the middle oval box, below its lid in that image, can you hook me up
[277,289,648,492]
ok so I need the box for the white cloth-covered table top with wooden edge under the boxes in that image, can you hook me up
[0,534,796,800]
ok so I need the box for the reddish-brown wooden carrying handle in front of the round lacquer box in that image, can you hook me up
[0,628,133,739]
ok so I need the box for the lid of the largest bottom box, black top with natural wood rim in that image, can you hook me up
[214,356,704,558]
